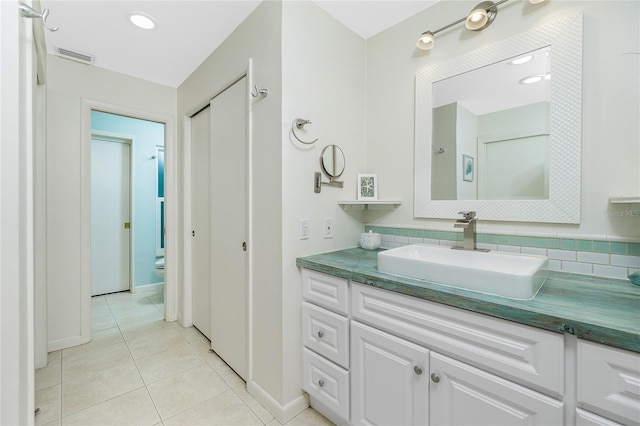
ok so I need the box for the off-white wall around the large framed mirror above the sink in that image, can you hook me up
[366,0,640,237]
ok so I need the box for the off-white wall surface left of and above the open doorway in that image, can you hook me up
[47,56,176,350]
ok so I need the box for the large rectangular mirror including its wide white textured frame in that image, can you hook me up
[414,14,582,223]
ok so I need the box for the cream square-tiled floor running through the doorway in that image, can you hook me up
[35,288,332,426]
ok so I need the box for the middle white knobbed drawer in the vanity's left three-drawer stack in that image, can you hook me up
[302,302,349,368]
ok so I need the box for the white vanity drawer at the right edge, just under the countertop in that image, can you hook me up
[577,340,640,425]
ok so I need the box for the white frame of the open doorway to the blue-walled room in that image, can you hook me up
[80,98,178,343]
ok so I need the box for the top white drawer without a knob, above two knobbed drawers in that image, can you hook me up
[302,269,349,315]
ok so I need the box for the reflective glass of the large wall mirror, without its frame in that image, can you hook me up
[431,46,551,200]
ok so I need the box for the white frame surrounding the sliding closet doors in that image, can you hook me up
[179,58,254,383]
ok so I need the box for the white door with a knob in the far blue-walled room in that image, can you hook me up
[91,138,131,296]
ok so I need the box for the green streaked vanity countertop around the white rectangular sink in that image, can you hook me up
[296,248,640,352]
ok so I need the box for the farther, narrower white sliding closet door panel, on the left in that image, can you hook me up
[191,107,211,340]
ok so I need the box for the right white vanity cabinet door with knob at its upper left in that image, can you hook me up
[429,352,564,426]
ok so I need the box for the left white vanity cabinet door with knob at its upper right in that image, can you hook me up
[351,321,429,425]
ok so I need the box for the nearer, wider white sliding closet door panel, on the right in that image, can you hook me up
[210,77,248,380]
